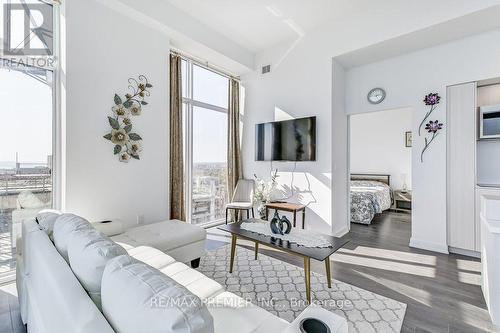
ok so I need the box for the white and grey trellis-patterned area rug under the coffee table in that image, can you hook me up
[198,245,406,333]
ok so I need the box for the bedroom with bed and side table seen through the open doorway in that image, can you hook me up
[348,108,413,230]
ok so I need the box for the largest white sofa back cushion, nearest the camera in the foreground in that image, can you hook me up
[101,255,214,333]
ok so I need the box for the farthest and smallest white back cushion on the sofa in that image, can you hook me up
[52,214,92,262]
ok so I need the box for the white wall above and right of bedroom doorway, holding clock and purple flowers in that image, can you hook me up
[346,30,500,252]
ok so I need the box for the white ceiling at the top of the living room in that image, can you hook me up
[165,0,498,53]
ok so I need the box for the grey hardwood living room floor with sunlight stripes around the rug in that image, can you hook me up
[208,212,494,333]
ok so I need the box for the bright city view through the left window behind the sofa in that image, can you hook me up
[0,67,52,278]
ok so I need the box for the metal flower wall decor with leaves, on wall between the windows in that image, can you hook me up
[104,75,153,163]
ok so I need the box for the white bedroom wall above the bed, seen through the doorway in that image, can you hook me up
[349,109,413,189]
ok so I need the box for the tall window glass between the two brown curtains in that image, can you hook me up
[182,59,229,225]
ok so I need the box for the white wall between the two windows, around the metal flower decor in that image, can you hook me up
[63,1,170,224]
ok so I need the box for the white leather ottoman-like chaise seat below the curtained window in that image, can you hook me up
[93,220,207,268]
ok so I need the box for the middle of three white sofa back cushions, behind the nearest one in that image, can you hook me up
[68,229,127,310]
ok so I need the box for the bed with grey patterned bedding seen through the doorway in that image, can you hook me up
[350,174,392,224]
